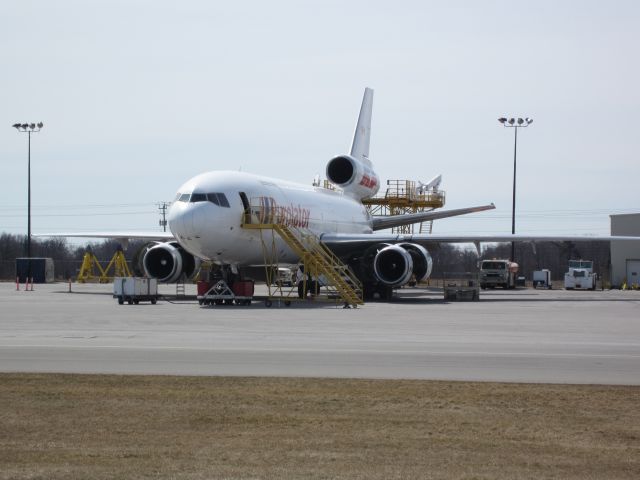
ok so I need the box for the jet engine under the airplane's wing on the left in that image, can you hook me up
[142,242,200,283]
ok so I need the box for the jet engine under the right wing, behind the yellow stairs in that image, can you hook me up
[373,243,433,287]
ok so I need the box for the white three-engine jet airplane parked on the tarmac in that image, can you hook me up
[48,88,640,298]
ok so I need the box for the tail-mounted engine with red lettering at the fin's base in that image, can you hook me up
[327,155,380,199]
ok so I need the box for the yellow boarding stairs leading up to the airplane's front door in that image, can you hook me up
[242,215,364,306]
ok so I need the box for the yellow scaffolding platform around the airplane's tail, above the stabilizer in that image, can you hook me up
[362,180,445,234]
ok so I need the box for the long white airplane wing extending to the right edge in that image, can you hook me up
[320,233,640,256]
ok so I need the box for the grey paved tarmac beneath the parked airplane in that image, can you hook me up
[0,283,640,385]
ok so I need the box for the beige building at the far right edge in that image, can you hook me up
[610,213,640,287]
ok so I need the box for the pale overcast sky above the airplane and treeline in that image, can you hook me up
[0,0,640,238]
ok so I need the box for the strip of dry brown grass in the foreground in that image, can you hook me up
[0,374,640,479]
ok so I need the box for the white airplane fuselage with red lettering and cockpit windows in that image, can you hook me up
[168,171,372,265]
